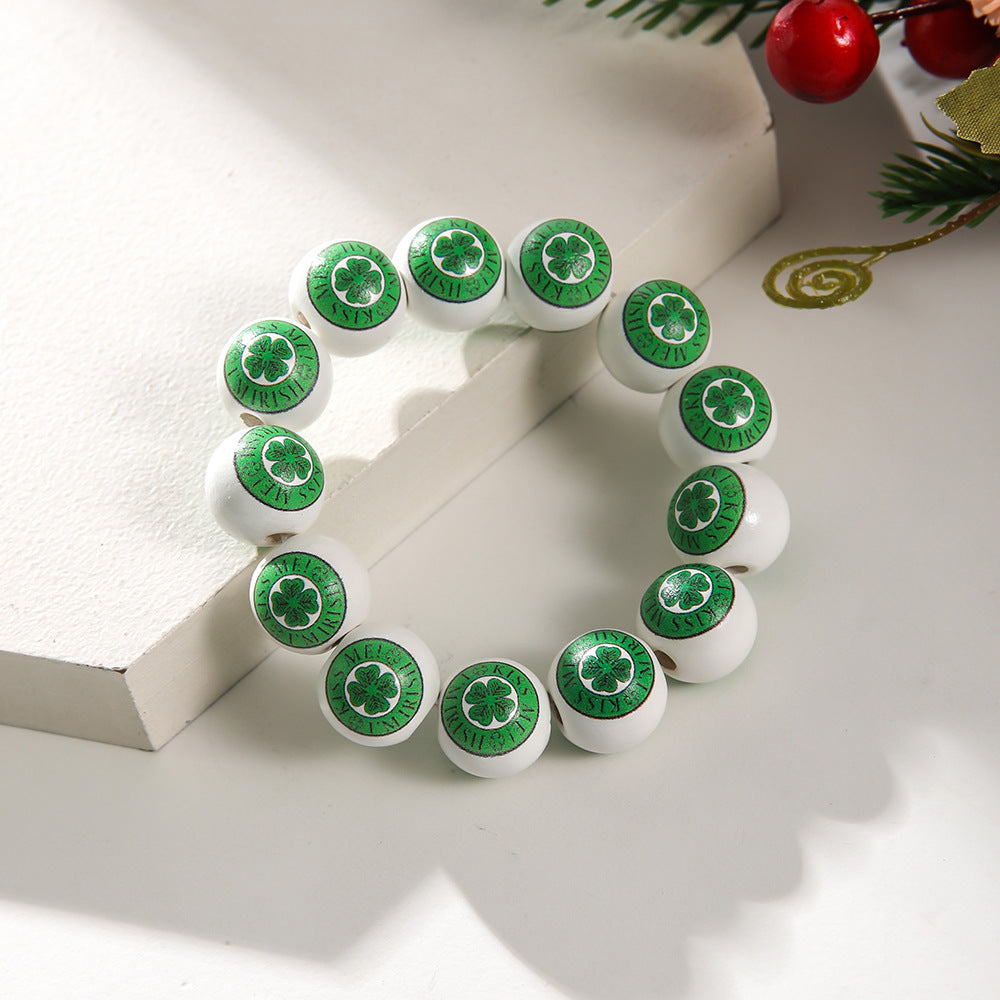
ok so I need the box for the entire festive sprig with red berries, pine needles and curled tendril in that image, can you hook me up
[543,0,1000,309]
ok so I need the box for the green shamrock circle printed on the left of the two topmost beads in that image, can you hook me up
[407,218,503,302]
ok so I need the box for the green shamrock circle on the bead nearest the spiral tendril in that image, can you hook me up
[622,278,709,368]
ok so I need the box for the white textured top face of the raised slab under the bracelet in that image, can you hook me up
[0,0,766,669]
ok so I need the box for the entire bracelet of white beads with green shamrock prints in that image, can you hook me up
[206,216,789,777]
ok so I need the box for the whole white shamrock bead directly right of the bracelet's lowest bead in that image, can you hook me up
[548,629,667,753]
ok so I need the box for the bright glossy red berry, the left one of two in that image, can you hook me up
[764,0,879,104]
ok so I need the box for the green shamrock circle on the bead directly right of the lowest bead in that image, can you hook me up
[556,629,656,719]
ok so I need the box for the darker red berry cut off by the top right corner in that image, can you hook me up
[903,4,1000,80]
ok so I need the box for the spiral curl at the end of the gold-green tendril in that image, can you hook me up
[764,247,885,309]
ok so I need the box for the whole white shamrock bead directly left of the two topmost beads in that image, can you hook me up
[288,240,406,357]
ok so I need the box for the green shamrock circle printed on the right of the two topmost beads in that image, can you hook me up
[519,219,611,309]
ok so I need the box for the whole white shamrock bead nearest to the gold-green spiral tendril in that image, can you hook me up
[597,278,711,392]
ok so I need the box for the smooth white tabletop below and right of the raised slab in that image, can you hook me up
[0,7,1000,1000]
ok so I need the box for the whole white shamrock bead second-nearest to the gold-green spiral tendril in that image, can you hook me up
[659,365,778,469]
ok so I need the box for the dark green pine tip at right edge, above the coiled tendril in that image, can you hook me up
[870,138,1000,228]
